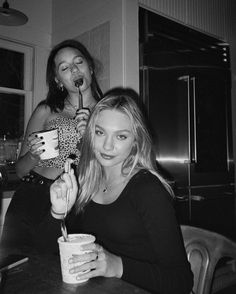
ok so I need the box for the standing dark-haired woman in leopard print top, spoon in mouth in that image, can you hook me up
[1,40,102,249]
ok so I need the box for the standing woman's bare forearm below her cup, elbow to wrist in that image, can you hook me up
[16,152,39,178]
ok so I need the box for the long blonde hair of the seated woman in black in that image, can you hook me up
[76,88,173,212]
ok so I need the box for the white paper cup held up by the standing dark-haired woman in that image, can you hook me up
[36,129,59,160]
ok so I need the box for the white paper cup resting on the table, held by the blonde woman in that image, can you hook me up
[57,234,95,284]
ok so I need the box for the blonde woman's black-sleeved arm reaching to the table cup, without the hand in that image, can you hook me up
[122,176,192,294]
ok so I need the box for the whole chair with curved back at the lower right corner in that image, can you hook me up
[181,225,236,294]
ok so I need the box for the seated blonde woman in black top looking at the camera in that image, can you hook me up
[37,89,193,294]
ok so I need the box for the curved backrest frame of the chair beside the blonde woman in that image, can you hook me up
[181,225,236,294]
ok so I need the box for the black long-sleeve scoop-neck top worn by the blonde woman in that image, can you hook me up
[36,170,193,294]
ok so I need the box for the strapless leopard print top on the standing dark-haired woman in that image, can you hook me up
[38,116,81,169]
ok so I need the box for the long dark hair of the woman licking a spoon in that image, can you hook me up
[40,39,102,112]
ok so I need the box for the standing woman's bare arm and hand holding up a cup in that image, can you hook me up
[16,105,50,178]
